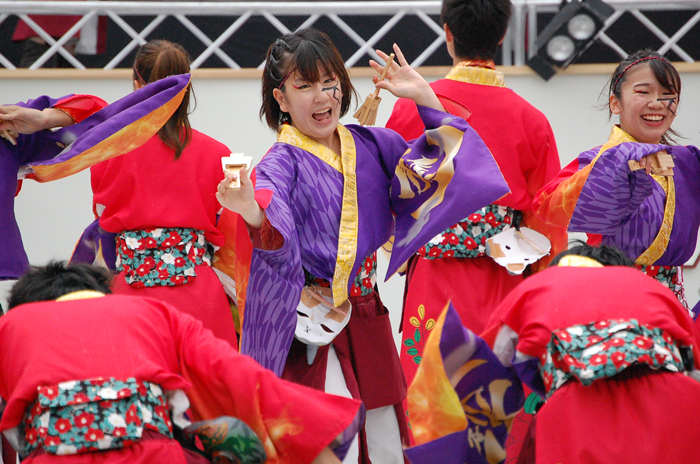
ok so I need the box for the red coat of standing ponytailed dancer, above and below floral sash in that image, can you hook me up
[90,130,237,347]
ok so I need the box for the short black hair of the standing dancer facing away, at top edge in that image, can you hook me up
[440,0,512,60]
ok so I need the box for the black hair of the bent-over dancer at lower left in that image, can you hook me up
[8,261,112,310]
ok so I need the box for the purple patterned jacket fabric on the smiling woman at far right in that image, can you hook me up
[569,142,700,266]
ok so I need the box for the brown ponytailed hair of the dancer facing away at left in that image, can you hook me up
[133,40,194,159]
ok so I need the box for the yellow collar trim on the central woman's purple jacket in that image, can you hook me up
[277,124,359,308]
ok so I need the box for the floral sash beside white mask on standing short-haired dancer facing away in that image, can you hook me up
[418,205,514,259]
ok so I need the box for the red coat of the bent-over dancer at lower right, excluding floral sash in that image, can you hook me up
[483,266,700,464]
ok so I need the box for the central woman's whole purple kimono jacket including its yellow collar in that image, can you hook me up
[241,107,509,375]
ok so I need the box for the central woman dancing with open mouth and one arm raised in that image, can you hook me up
[218,29,508,464]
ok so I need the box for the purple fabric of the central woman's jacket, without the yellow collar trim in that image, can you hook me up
[241,108,508,375]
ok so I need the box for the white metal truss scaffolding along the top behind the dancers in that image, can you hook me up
[0,0,700,69]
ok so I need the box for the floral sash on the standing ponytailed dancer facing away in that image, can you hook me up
[117,228,211,287]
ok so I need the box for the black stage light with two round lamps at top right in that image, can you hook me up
[527,0,615,80]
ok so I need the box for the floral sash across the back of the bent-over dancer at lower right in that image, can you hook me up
[541,319,684,397]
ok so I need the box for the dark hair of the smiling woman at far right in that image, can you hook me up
[603,49,681,144]
